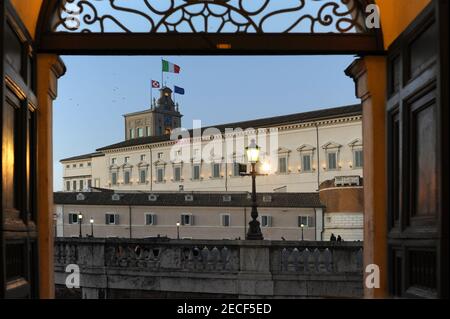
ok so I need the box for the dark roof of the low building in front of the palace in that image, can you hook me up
[53,192,323,208]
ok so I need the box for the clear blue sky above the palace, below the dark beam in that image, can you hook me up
[53,56,358,190]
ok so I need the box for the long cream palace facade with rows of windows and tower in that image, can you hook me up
[61,88,363,193]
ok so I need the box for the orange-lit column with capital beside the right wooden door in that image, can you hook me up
[346,56,388,298]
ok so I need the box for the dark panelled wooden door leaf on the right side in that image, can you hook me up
[387,1,448,298]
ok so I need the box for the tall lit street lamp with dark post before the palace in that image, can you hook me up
[241,140,264,240]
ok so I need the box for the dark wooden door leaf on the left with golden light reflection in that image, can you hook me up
[0,1,38,298]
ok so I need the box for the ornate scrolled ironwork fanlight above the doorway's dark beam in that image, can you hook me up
[49,0,370,34]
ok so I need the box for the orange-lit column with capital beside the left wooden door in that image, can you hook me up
[36,54,66,298]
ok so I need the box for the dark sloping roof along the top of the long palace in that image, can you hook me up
[97,104,362,151]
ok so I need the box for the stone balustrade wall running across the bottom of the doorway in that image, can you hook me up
[55,238,363,298]
